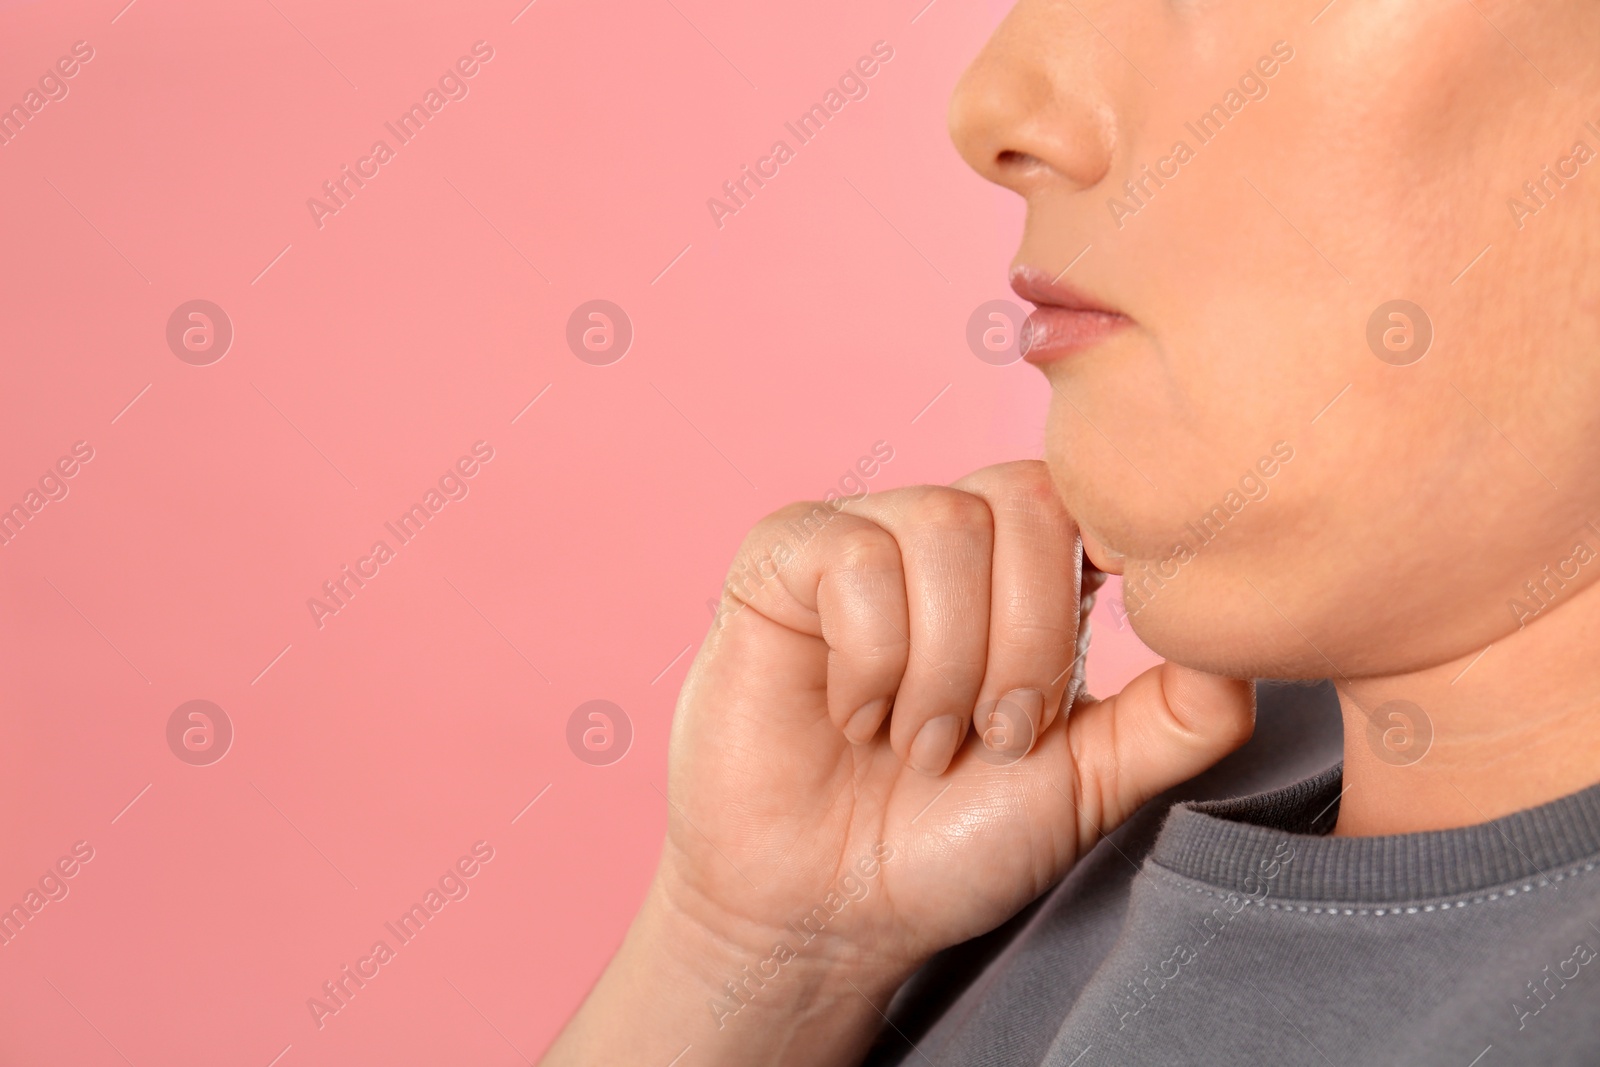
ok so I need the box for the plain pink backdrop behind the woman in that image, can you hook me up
[0,0,1150,1067]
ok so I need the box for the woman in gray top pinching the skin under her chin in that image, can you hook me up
[546,0,1600,1067]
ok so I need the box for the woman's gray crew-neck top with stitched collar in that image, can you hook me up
[866,683,1600,1067]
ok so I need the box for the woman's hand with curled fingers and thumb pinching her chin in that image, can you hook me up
[654,462,1254,989]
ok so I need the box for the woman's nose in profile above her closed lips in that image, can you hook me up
[949,0,1118,197]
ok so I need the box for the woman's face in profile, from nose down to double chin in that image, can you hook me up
[950,0,1600,677]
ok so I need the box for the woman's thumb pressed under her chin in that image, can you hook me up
[1066,662,1256,849]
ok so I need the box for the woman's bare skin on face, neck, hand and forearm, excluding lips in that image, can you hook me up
[544,0,1600,1065]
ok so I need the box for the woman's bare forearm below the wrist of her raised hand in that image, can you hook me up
[541,888,909,1067]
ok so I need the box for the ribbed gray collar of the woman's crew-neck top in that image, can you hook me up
[1150,765,1600,904]
